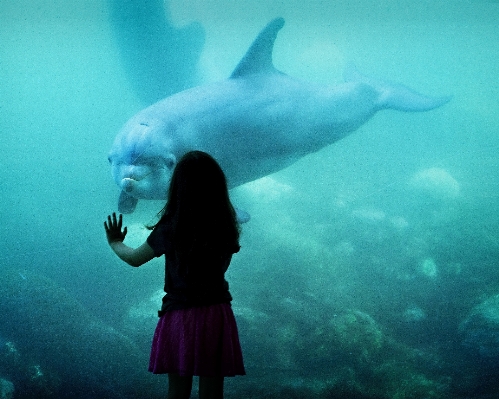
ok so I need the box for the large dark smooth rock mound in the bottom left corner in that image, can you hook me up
[0,269,164,399]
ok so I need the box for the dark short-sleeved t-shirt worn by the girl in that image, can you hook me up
[147,223,239,316]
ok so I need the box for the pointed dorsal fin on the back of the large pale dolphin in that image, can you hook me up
[230,18,284,78]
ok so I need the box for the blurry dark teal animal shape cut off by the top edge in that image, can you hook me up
[107,0,205,105]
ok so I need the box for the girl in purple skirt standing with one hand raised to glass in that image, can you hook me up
[104,151,245,399]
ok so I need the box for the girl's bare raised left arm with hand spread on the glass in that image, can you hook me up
[104,212,154,267]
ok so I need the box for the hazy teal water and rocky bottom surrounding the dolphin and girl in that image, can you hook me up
[0,0,499,399]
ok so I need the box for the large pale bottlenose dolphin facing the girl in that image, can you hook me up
[109,18,450,213]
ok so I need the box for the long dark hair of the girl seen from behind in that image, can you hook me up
[151,151,240,257]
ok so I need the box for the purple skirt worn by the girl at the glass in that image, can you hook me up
[149,303,246,377]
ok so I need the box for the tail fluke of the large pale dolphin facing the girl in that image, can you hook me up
[344,64,452,112]
